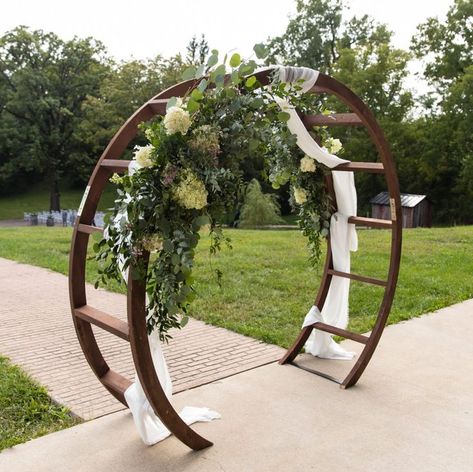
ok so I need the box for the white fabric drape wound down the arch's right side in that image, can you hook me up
[277,67,358,360]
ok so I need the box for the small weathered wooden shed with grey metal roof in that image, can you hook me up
[370,192,432,228]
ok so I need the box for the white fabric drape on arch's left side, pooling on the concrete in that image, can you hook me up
[110,161,220,446]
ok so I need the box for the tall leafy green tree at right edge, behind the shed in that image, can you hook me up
[412,0,473,223]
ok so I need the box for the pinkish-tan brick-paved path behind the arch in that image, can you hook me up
[0,258,283,419]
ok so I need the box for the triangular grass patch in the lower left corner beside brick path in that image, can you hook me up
[0,356,79,451]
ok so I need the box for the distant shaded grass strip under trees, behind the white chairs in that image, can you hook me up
[0,186,115,220]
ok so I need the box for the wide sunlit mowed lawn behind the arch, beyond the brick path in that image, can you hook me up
[0,226,473,347]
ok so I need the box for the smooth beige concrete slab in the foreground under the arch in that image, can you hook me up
[0,300,473,472]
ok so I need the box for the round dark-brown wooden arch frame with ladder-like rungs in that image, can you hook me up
[69,69,402,450]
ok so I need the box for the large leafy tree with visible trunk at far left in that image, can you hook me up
[0,27,107,210]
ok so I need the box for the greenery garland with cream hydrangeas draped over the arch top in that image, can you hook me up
[94,45,341,340]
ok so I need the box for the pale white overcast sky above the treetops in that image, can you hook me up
[0,0,453,91]
